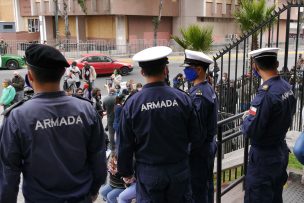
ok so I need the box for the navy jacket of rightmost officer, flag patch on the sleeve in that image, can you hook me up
[242,76,296,148]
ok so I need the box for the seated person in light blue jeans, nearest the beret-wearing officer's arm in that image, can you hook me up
[99,154,125,203]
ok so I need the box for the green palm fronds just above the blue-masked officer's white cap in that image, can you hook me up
[172,25,213,52]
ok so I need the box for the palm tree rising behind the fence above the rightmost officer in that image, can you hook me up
[234,0,275,50]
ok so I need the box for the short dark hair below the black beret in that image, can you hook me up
[29,66,65,83]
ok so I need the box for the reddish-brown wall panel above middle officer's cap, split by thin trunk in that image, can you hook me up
[128,16,172,43]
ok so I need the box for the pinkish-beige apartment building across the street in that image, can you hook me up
[0,0,297,44]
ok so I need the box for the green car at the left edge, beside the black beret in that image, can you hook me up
[0,54,25,70]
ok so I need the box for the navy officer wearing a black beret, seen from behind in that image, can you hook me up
[0,44,106,203]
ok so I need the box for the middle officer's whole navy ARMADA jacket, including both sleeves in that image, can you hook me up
[117,82,201,176]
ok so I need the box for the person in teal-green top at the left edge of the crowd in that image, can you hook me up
[0,79,16,110]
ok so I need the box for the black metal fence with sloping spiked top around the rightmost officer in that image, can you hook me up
[213,1,304,203]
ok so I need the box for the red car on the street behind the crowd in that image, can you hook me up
[69,54,133,75]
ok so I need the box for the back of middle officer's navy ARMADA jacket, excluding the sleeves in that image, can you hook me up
[124,82,197,165]
